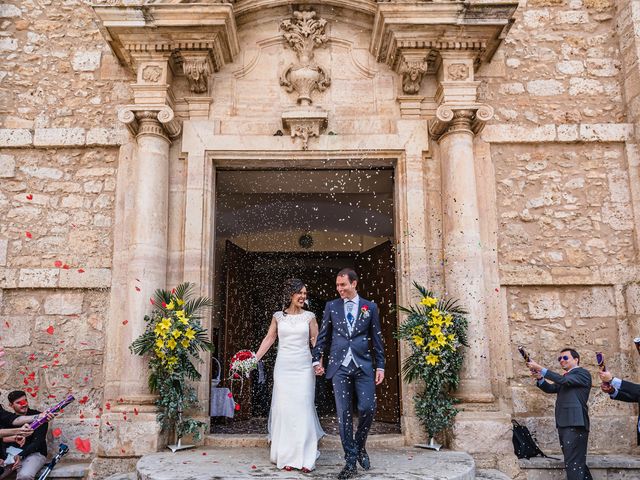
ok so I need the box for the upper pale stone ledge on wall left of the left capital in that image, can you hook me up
[0,128,129,148]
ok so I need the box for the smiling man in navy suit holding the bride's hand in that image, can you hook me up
[313,268,384,479]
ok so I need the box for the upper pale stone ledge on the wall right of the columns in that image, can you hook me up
[481,123,633,143]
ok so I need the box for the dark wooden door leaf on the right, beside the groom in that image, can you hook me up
[355,241,400,423]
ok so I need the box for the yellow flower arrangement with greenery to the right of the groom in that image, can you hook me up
[396,282,467,438]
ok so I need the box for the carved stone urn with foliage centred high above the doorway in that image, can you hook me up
[280,11,331,106]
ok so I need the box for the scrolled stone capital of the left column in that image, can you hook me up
[118,104,182,140]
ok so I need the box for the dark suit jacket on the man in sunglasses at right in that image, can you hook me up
[538,367,591,430]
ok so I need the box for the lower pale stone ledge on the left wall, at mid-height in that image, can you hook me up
[0,268,111,289]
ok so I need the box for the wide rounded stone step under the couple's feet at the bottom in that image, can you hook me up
[136,442,476,480]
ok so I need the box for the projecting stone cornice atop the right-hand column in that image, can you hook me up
[369,0,518,70]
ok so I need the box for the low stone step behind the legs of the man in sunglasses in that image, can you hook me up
[518,453,640,480]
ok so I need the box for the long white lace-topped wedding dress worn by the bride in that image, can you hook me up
[268,311,325,470]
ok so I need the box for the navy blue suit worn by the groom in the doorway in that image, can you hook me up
[313,297,384,465]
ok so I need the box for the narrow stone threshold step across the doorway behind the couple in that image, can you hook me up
[204,433,404,449]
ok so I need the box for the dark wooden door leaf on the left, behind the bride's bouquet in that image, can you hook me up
[220,240,252,420]
